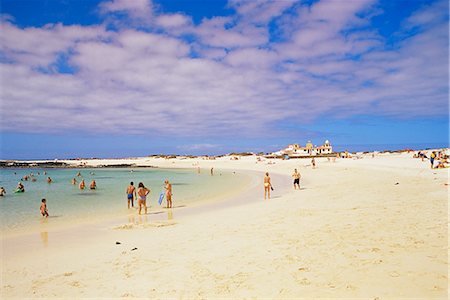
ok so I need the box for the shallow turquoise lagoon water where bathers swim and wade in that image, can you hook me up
[0,169,245,232]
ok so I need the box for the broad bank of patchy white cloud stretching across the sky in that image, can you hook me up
[0,1,448,138]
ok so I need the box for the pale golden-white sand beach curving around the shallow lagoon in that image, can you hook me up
[1,153,449,299]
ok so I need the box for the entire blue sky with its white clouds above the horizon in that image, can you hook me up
[0,0,449,159]
